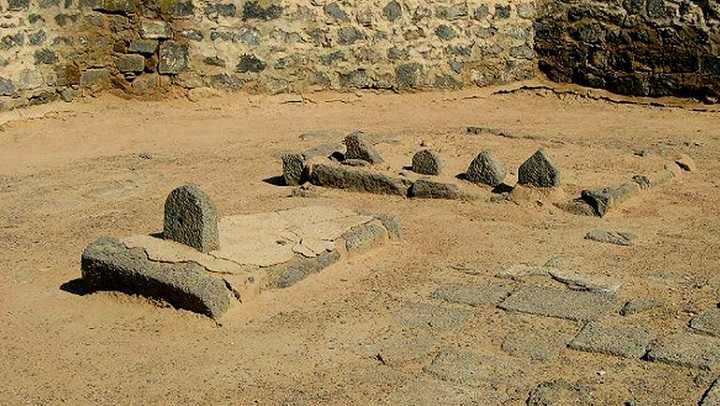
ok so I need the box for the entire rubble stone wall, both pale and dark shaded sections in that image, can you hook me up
[0,0,720,110]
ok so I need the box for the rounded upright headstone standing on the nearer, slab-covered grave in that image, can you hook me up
[163,185,220,253]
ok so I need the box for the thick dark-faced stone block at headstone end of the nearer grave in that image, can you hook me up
[82,237,232,318]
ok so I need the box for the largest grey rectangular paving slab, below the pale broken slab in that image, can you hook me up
[500,286,613,321]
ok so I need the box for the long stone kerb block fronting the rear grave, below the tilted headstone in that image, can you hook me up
[309,163,411,196]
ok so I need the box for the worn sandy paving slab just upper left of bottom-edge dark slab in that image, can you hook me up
[424,348,527,387]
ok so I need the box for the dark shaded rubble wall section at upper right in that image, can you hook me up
[535,0,720,101]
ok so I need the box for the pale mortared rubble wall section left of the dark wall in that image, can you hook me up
[0,0,537,109]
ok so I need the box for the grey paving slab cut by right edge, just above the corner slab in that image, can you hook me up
[646,333,720,370]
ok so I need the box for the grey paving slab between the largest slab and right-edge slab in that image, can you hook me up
[568,322,652,358]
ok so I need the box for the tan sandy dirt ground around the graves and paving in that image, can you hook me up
[0,83,720,405]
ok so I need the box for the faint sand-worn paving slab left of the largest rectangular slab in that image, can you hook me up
[394,303,472,330]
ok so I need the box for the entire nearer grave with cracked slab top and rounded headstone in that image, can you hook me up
[81,185,400,318]
